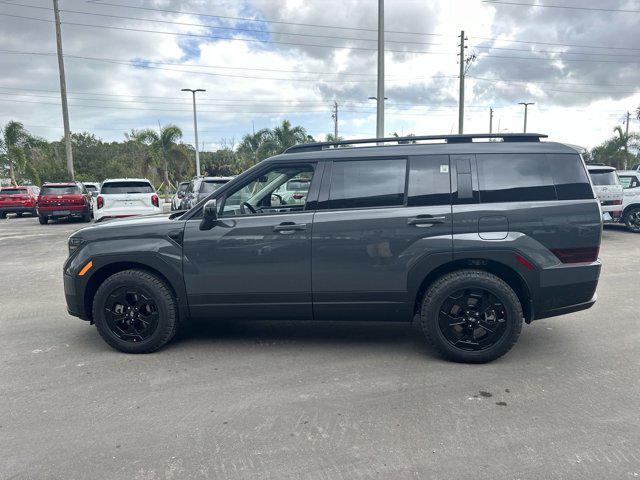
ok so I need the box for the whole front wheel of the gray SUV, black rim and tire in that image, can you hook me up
[93,270,178,353]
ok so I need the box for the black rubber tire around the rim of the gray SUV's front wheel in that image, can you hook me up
[92,270,178,353]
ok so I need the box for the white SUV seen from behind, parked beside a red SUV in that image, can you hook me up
[94,178,162,222]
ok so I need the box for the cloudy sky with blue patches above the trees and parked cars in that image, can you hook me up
[0,0,640,150]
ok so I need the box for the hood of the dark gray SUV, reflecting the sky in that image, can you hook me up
[71,213,185,241]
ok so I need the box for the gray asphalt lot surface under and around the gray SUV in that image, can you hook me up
[0,218,640,480]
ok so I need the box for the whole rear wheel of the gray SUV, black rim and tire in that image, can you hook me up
[420,270,523,363]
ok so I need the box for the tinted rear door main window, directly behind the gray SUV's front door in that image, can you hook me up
[329,159,407,208]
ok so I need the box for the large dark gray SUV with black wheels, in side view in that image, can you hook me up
[64,134,602,363]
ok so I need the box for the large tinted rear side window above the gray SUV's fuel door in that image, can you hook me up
[476,154,556,203]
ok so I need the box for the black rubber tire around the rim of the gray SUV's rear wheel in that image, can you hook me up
[420,270,523,363]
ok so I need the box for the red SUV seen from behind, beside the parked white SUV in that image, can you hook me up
[38,182,93,225]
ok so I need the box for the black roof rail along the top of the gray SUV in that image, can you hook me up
[284,133,548,153]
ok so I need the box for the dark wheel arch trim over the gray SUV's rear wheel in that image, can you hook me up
[413,258,534,323]
